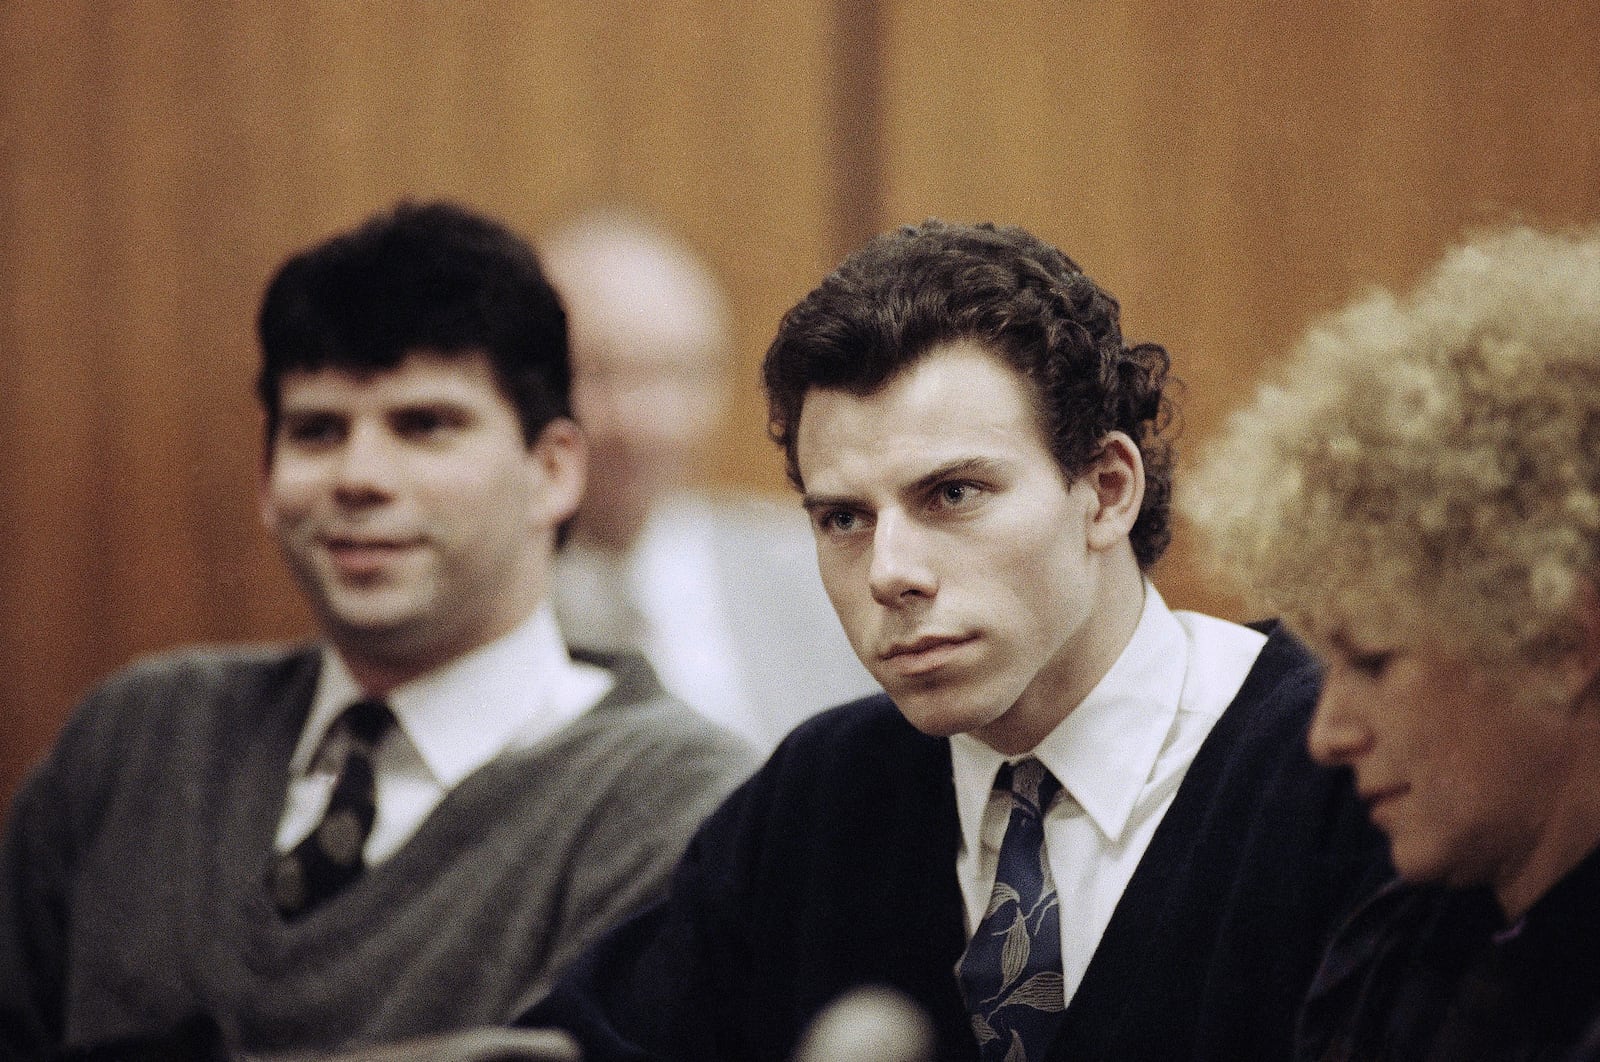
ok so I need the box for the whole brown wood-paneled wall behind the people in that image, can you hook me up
[0,0,1600,795]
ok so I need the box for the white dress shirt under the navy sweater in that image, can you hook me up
[950,584,1266,1003]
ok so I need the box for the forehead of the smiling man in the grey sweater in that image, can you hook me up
[280,350,509,411]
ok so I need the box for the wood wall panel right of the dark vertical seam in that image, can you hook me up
[883,0,1600,616]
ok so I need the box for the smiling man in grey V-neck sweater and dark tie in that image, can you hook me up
[0,203,750,1059]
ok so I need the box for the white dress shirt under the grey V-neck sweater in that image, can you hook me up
[274,605,613,864]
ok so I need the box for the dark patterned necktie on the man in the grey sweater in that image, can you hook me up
[267,699,395,918]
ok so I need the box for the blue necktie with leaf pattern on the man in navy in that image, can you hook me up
[955,758,1066,1062]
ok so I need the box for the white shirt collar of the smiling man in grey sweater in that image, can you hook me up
[290,605,613,789]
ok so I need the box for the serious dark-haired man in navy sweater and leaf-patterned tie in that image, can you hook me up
[523,221,1381,1062]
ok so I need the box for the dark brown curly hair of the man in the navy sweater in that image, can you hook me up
[762,219,1173,569]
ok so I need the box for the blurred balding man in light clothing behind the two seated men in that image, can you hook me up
[541,213,875,747]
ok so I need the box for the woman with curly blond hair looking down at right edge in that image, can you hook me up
[1192,229,1600,1062]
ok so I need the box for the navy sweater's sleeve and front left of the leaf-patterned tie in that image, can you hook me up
[517,694,976,1062]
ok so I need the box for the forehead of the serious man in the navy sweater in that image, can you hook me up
[795,341,1054,493]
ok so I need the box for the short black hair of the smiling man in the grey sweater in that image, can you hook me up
[256,200,571,453]
